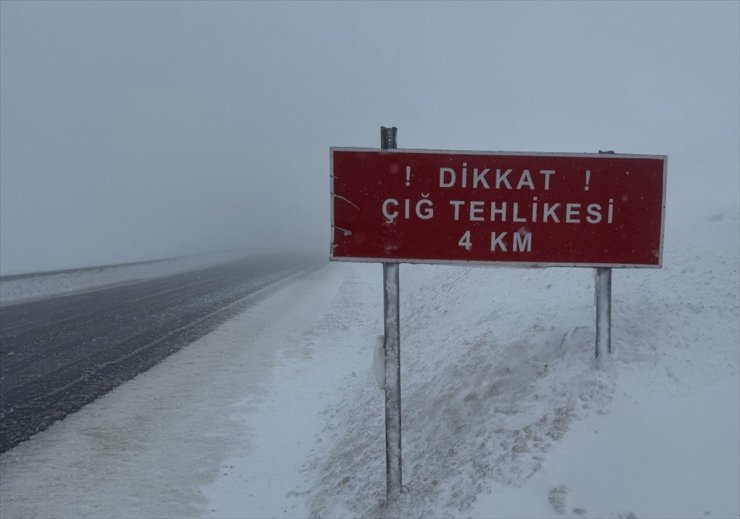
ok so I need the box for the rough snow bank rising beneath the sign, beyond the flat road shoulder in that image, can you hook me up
[307,198,740,517]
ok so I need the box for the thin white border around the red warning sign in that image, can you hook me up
[329,146,668,268]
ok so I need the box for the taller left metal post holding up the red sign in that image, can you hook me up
[380,127,402,504]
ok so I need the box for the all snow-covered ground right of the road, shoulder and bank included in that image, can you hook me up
[0,198,740,519]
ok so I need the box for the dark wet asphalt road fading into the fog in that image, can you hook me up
[0,256,320,452]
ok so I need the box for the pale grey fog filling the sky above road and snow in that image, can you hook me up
[0,1,740,274]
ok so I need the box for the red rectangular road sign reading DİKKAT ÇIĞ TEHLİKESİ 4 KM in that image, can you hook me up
[331,148,666,267]
